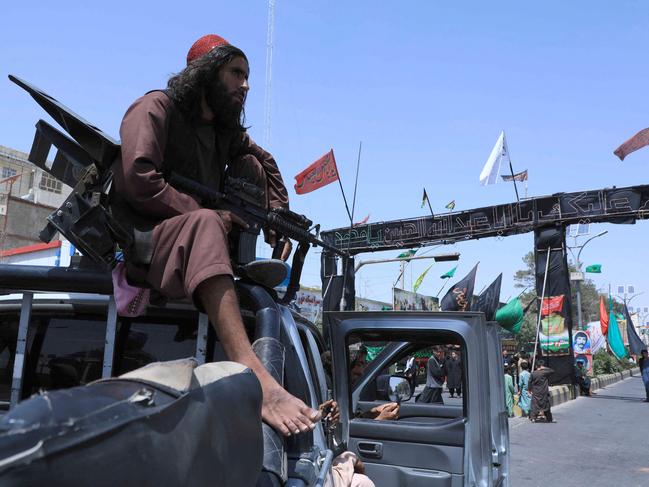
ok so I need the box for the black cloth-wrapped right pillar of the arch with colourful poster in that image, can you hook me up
[534,226,575,384]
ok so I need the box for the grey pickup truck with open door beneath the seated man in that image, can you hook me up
[0,265,509,487]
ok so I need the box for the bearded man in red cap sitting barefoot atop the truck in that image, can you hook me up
[111,35,320,435]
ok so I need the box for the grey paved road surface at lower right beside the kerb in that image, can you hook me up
[509,377,649,487]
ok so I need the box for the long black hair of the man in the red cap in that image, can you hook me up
[167,45,248,131]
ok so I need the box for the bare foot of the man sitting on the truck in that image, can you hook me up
[261,383,322,436]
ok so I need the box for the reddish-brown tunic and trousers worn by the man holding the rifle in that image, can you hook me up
[113,91,288,299]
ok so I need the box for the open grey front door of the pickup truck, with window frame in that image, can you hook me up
[329,312,506,487]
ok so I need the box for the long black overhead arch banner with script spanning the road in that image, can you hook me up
[321,185,649,254]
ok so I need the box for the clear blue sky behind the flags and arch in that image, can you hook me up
[0,0,649,316]
